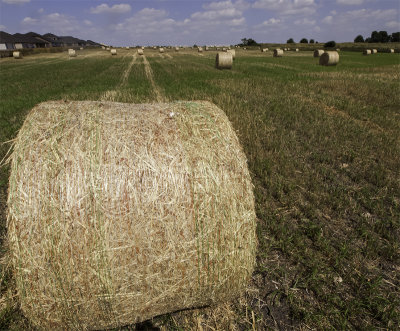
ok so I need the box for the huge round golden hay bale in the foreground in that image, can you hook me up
[7,100,256,330]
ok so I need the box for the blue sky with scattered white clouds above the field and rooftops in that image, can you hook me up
[0,0,400,46]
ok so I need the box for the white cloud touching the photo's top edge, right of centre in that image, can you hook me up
[253,0,317,16]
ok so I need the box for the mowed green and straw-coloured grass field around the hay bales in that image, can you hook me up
[0,49,400,330]
